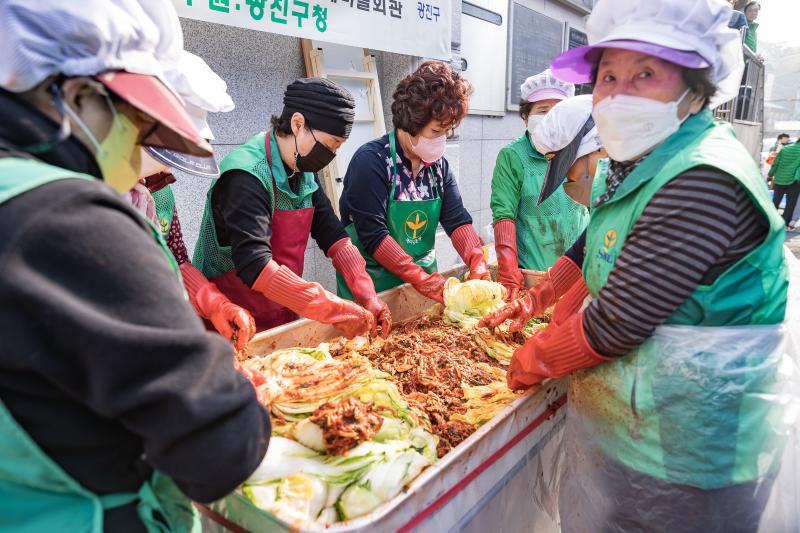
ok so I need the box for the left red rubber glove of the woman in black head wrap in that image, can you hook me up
[253,259,375,338]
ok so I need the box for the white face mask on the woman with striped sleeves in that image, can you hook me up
[592,89,689,162]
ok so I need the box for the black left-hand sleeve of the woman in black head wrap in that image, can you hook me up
[211,170,272,287]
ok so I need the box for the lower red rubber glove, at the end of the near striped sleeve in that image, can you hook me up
[506,313,611,389]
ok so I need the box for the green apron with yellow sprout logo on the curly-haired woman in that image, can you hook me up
[336,131,443,300]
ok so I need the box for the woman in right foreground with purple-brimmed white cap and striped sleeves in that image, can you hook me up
[484,0,800,532]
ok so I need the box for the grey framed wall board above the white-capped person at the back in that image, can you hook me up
[508,2,564,110]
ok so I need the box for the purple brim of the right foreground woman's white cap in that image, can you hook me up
[550,39,711,83]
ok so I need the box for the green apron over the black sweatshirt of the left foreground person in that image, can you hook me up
[0,157,200,533]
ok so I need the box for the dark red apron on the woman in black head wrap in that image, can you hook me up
[211,132,314,331]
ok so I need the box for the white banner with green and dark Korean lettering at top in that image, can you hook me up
[172,0,452,61]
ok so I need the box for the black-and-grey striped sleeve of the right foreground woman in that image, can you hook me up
[584,167,766,356]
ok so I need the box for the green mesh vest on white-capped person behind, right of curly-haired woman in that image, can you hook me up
[506,134,589,271]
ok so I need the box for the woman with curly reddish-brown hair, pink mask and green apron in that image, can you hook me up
[337,61,489,302]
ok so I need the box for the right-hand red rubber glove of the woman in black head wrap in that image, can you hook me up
[328,237,392,339]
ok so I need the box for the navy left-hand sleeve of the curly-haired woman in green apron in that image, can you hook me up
[339,148,389,255]
